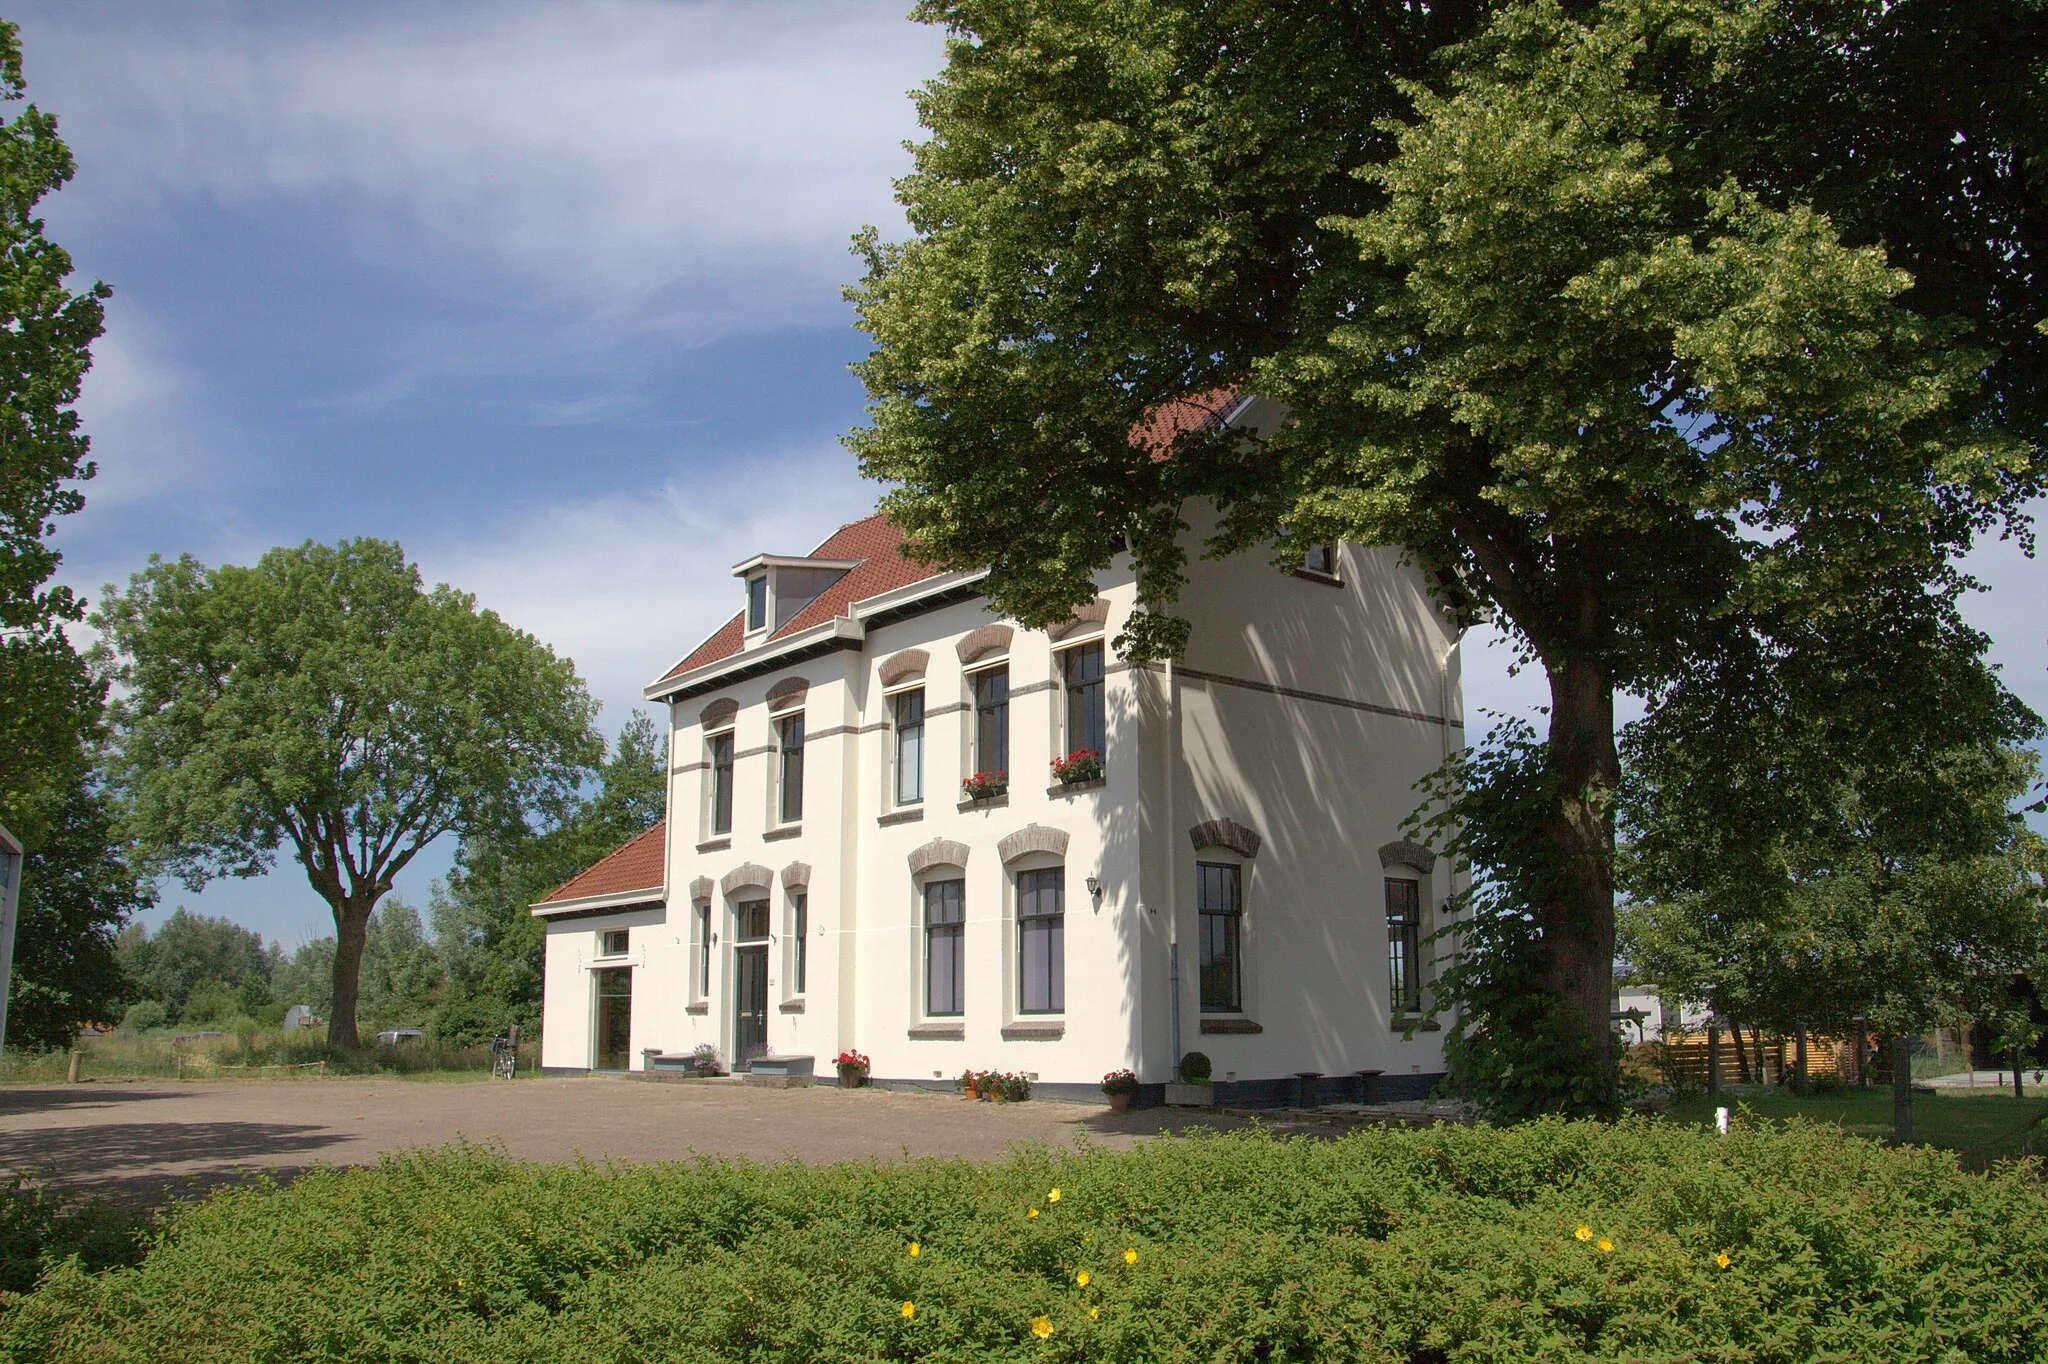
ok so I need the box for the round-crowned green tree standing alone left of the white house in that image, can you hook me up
[94,541,600,1049]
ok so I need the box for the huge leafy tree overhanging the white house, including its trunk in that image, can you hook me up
[852,0,2048,1063]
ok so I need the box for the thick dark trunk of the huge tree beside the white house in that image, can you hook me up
[1538,657,1622,1069]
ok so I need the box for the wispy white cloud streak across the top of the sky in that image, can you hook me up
[25,0,940,342]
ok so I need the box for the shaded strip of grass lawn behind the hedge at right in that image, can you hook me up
[1667,1088,2048,1165]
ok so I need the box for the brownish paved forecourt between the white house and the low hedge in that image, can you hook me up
[0,1077,1329,1200]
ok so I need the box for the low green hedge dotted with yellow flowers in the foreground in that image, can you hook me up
[0,1122,2048,1364]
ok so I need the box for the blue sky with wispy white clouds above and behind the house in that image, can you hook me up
[19,0,2048,944]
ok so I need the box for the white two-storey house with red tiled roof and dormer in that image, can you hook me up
[535,399,1462,1104]
